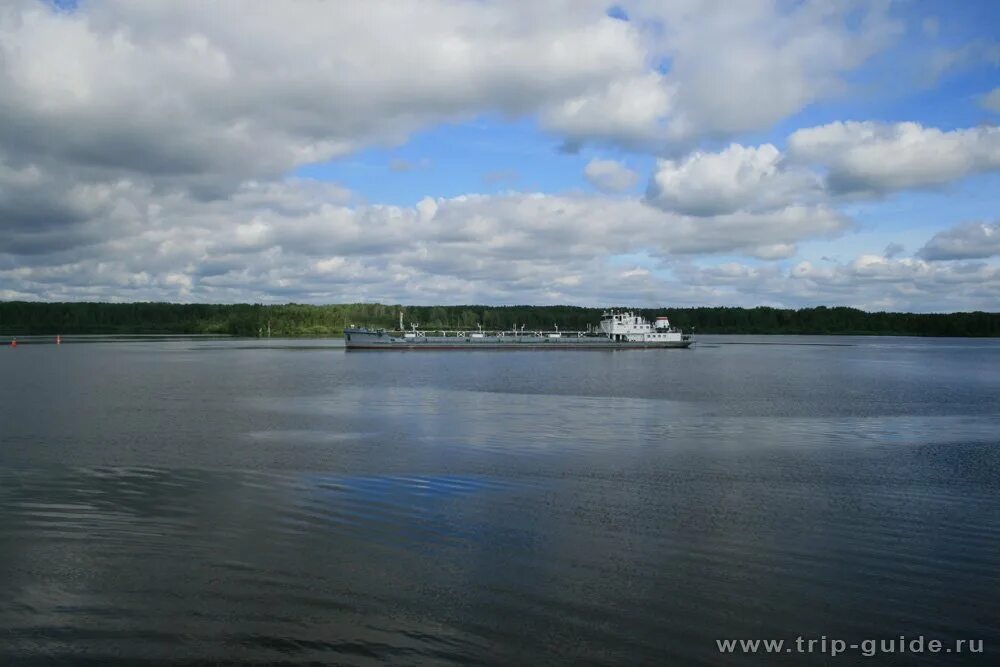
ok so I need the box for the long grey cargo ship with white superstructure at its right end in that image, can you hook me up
[344,310,694,350]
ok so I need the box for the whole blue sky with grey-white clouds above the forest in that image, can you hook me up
[0,0,1000,311]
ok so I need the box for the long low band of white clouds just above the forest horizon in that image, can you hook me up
[0,174,1000,311]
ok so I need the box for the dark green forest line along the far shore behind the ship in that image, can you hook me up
[0,301,1000,336]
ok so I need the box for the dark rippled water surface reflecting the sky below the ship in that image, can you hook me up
[0,337,1000,665]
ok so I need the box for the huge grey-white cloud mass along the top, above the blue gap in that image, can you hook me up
[0,0,896,183]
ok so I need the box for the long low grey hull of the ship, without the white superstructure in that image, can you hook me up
[344,329,694,350]
